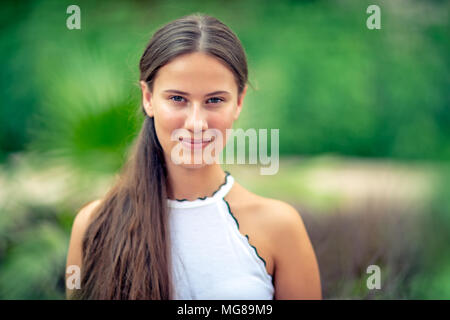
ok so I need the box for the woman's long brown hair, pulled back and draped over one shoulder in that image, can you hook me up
[72,13,248,300]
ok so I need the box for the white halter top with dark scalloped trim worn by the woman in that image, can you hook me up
[167,171,274,300]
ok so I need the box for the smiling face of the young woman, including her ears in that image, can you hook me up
[141,52,247,167]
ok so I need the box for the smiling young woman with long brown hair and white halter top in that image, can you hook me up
[67,14,321,299]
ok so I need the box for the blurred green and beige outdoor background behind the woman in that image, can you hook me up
[0,0,450,299]
